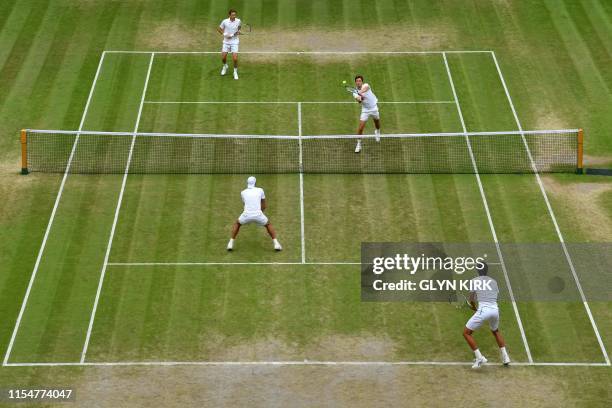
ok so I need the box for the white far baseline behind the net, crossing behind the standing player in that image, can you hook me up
[105,50,493,55]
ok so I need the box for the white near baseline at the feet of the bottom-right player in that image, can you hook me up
[6,360,608,370]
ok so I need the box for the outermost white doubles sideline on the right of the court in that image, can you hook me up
[491,52,611,365]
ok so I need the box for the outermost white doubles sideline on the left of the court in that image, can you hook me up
[2,52,106,365]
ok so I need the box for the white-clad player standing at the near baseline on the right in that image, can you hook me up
[463,264,510,368]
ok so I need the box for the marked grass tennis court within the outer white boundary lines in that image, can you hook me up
[4,51,610,365]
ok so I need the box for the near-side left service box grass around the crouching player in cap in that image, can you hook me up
[111,174,301,262]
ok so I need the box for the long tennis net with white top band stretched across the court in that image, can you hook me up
[21,129,582,174]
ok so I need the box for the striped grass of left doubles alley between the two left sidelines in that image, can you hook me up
[6,50,154,361]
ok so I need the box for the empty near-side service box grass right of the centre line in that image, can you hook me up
[304,175,498,262]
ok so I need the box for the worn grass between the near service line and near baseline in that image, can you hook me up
[90,266,532,361]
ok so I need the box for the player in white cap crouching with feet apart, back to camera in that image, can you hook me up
[227,176,283,251]
